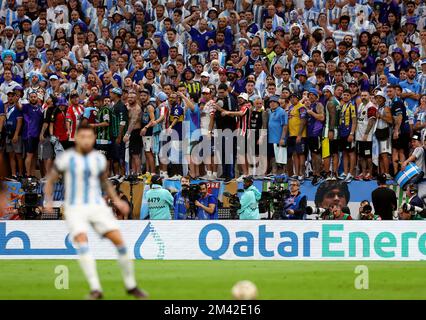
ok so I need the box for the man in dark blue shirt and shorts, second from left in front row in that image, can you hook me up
[18,92,43,176]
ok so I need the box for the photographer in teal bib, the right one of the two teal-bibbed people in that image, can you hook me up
[238,176,262,220]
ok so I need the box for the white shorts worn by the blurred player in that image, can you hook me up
[64,204,119,239]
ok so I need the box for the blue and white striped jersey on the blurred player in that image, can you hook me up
[55,149,107,206]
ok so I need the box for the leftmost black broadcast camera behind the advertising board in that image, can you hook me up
[18,178,42,220]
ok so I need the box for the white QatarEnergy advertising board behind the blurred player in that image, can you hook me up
[0,220,426,261]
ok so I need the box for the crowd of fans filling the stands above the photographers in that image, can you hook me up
[0,0,426,185]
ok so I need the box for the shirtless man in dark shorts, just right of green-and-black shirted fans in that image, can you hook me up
[123,91,142,174]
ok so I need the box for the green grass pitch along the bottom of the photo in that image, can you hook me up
[0,260,426,300]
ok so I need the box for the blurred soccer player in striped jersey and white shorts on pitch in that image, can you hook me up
[45,125,147,300]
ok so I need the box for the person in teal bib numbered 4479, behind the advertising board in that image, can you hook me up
[146,175,173,220]
